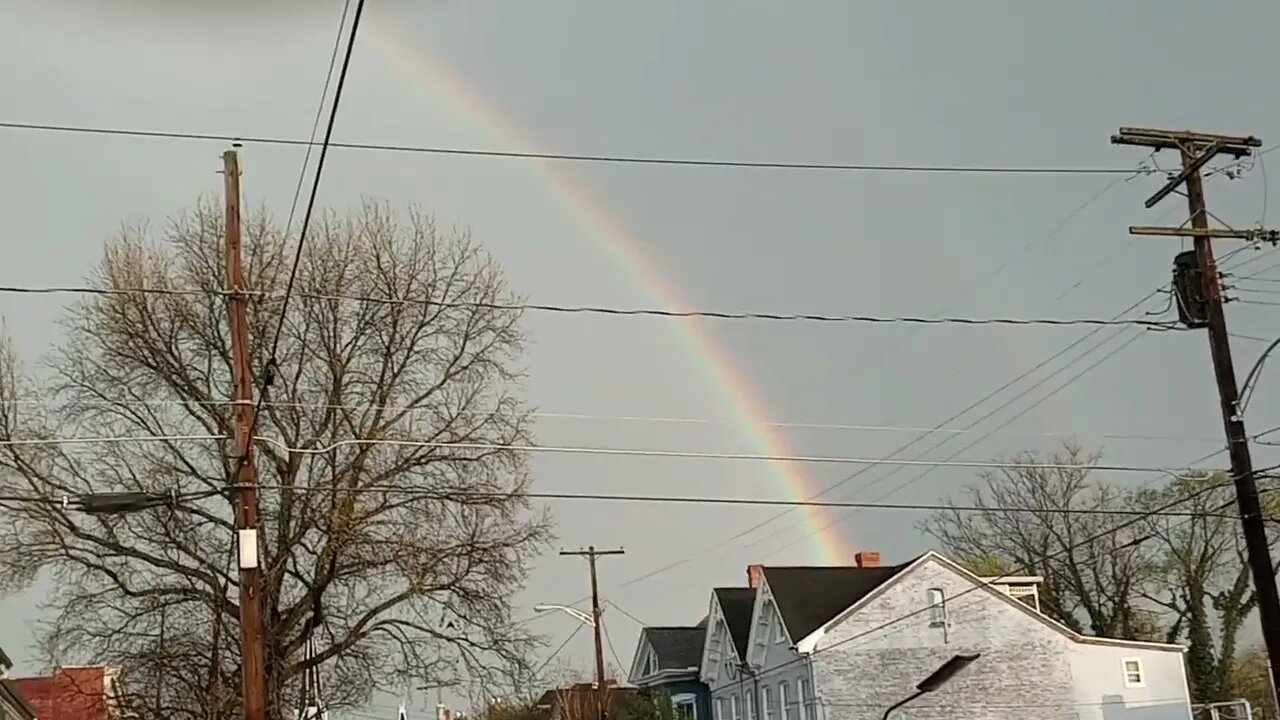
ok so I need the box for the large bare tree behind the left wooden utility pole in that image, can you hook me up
[0,202,549,719]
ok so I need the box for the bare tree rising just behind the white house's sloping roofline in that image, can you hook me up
[922,441,1153,639]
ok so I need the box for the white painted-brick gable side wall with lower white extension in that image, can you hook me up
[810,557,1189,720]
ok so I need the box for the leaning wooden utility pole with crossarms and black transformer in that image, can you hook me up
[1111,128,1280,694]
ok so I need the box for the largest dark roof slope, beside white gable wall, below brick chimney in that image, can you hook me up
[764,560,914,642]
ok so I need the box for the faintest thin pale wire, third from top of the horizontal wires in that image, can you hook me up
[0,397,1219,442]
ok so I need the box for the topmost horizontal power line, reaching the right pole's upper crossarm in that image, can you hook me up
[0,119,1152,176]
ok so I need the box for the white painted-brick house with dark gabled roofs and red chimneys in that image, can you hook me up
[699,552,1190,720]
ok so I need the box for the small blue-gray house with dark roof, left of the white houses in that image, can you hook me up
[628,620,712,720]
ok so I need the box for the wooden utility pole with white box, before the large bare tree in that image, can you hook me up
[223,150,266,720]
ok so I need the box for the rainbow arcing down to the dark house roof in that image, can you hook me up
[361,23,851,565]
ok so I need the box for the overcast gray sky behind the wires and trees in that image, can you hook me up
[0,0,1280,705]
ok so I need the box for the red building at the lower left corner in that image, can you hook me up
[13,665,120,720]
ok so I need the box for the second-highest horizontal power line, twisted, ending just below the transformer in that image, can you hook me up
[0,286,1183,327]
